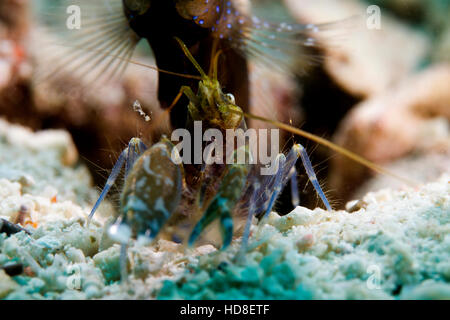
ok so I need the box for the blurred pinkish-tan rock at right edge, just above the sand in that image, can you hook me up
[330,64,450,199]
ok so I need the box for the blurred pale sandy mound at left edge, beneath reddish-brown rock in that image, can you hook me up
[0,118,97,205]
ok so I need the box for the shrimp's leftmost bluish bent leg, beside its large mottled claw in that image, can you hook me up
[88,138,147,221]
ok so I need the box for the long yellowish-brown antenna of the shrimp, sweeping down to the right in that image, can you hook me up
[236,109,417,186]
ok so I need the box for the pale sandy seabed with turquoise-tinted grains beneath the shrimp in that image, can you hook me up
[0,120,450,299]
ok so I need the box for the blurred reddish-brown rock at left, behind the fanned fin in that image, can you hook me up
[0,11,164,182]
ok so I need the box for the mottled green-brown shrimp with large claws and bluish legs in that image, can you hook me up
[90,39,331,277]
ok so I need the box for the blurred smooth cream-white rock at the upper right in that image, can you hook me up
[285,0,428,97]
